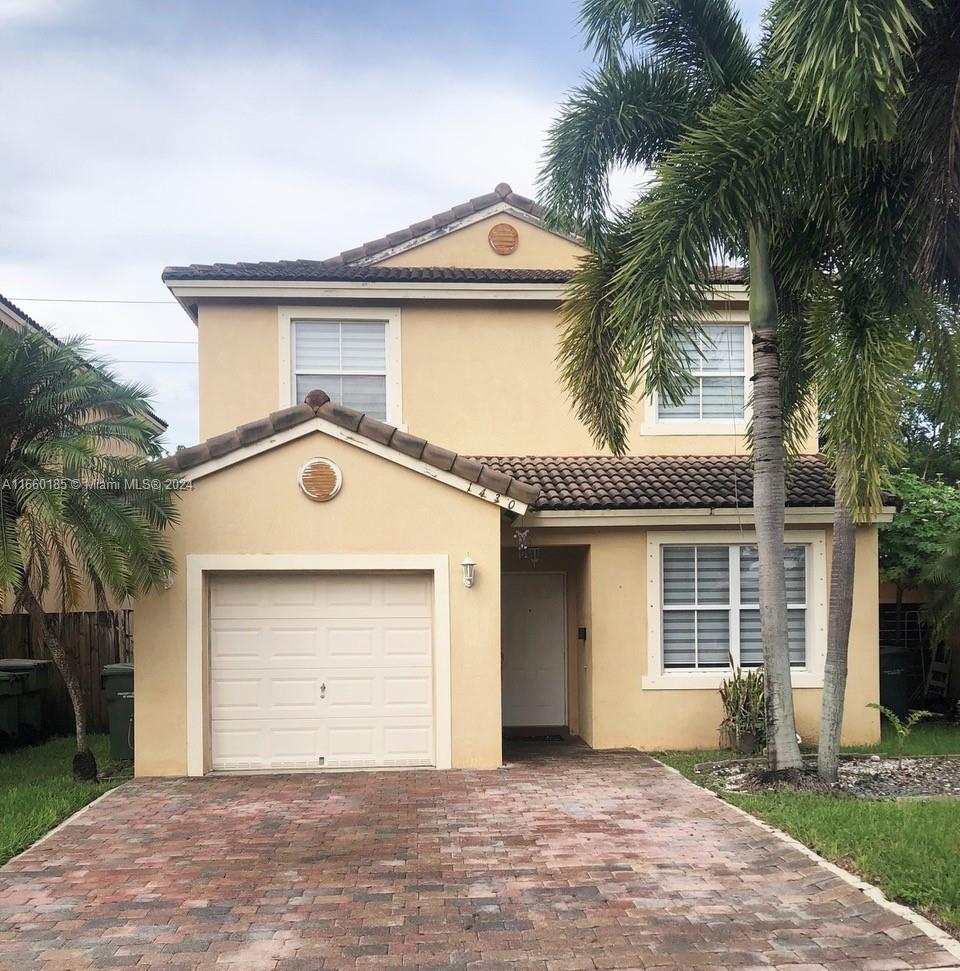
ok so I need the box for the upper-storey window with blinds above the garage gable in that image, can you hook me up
[293,320,387,420]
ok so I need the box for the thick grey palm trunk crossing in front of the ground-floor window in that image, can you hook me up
[750,224,802,773]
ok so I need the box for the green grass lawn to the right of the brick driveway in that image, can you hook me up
[655,724,960,934]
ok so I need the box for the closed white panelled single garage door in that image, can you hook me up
[210,573,434,769]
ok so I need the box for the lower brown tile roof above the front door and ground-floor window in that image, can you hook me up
[476,455,833,510]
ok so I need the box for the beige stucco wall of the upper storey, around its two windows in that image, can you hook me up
[198,300,816,455]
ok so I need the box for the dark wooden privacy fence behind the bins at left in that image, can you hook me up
[0,610,133,734]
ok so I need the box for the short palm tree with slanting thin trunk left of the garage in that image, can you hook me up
[0,330,176,779]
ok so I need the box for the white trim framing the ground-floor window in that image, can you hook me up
[642,529,827,691]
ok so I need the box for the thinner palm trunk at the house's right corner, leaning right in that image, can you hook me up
[817,496,857,782]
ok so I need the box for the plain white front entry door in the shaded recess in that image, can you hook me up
[500,573,567,726]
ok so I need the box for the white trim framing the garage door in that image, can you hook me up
[186,553,459,776]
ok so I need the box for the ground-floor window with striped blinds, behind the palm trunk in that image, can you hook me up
[660,544,808,670]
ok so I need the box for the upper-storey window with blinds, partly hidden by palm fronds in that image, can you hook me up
[657,324,747,421]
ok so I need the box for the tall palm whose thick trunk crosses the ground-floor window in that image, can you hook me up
[541,0,816,772]
